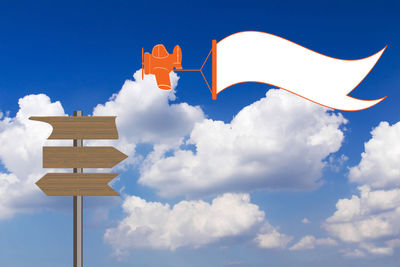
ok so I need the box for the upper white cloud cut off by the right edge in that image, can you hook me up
[349,122,400,188]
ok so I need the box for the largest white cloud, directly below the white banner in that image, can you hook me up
[139,90,346,196]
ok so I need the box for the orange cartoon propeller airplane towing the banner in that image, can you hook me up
[142,44,182,90]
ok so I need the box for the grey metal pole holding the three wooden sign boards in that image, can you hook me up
[74,110,83,267]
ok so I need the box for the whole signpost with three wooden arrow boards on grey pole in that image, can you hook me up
[29,111,128,267]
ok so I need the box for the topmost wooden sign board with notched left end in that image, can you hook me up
[29,116,118,139]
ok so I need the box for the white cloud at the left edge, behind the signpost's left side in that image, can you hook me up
[0,94,65,219]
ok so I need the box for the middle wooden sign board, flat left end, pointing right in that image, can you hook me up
[43,146,128,168]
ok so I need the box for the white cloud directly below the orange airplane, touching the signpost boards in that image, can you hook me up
[92,70,204,163]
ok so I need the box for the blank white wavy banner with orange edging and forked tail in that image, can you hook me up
[213,31,386,110]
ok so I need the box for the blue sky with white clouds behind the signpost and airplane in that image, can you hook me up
[0,1,400,267]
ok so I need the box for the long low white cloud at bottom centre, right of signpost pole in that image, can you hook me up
[104,193,285,255]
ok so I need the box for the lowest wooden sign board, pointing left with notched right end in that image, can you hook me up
[36,173,119,196]
